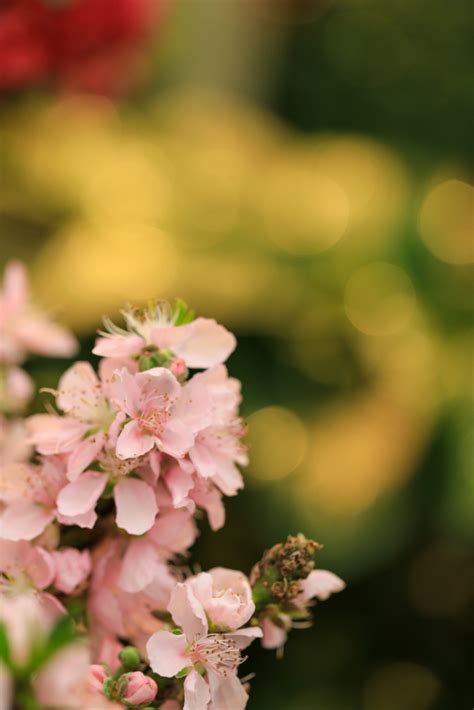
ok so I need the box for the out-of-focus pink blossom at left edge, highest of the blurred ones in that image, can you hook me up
[0,261,77,363]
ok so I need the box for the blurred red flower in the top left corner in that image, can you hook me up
[0,0,168,94]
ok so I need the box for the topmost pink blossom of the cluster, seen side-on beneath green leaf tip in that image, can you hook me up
[93,303,236,368]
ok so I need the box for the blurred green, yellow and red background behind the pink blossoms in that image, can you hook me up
[0,0,474,710]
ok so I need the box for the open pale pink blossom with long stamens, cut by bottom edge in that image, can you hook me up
[147,583,262,710]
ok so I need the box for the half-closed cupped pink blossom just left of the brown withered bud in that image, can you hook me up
[186,567,255,631]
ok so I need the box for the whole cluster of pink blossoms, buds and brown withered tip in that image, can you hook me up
[0,264,344,710]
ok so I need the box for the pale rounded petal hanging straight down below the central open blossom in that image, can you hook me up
[114,478,158,535]
